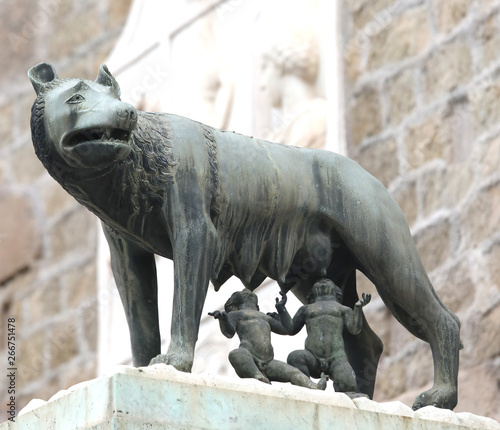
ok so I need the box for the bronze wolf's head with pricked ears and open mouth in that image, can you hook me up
[28,63,137,171]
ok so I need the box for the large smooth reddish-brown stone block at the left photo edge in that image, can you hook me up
[0,189,41,282]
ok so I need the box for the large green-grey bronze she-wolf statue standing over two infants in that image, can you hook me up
[28,63,460,409]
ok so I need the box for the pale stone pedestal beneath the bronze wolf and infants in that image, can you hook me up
[0,364,500,430]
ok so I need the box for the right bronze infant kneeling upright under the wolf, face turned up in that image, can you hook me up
[287,279,371,393]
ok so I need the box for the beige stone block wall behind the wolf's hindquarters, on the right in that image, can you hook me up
[341,0,500,419]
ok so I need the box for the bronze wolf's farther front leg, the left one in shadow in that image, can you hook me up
[103,224,161,366]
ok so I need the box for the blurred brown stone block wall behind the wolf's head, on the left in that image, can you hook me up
[0,0,130,422]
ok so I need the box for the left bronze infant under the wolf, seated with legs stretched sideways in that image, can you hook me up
[209,290,326,390]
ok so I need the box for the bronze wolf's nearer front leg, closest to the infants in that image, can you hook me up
[151,219,215,372]
